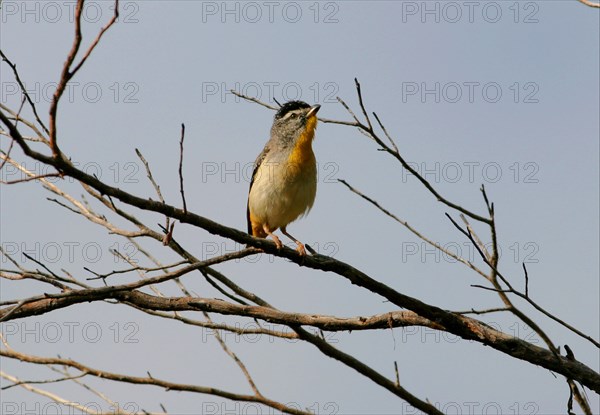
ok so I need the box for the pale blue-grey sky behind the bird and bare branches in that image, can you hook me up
[0,0,600,414]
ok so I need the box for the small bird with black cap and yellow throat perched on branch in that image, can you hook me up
[246,101,321,256]
